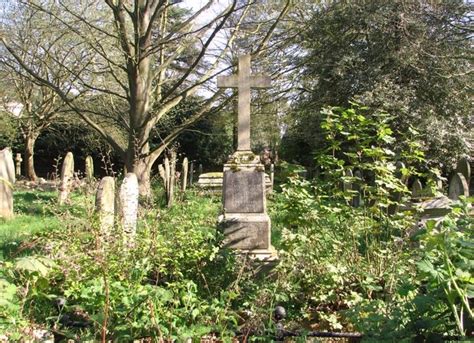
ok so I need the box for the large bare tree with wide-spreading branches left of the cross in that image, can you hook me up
[3,0,286,195]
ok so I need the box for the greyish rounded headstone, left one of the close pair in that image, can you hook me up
[95,176,115,239]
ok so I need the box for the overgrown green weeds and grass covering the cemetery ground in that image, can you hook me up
[0,173,473,342]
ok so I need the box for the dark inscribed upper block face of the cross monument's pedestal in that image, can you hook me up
[223,170,265,213]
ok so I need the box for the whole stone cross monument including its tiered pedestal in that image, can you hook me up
[217,55,276,260]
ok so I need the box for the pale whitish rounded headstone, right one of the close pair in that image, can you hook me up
[120,173,139,246]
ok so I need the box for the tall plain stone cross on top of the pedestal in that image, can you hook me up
[217,55,271,151]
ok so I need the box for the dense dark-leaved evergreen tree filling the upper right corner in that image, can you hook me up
[286,0,473,169]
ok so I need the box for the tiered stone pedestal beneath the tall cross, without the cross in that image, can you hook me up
[221,151,277,262]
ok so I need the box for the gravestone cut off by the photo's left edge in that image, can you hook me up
[0,148,15,219]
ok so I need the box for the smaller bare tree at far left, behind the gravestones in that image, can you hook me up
[0,4,67,180]
